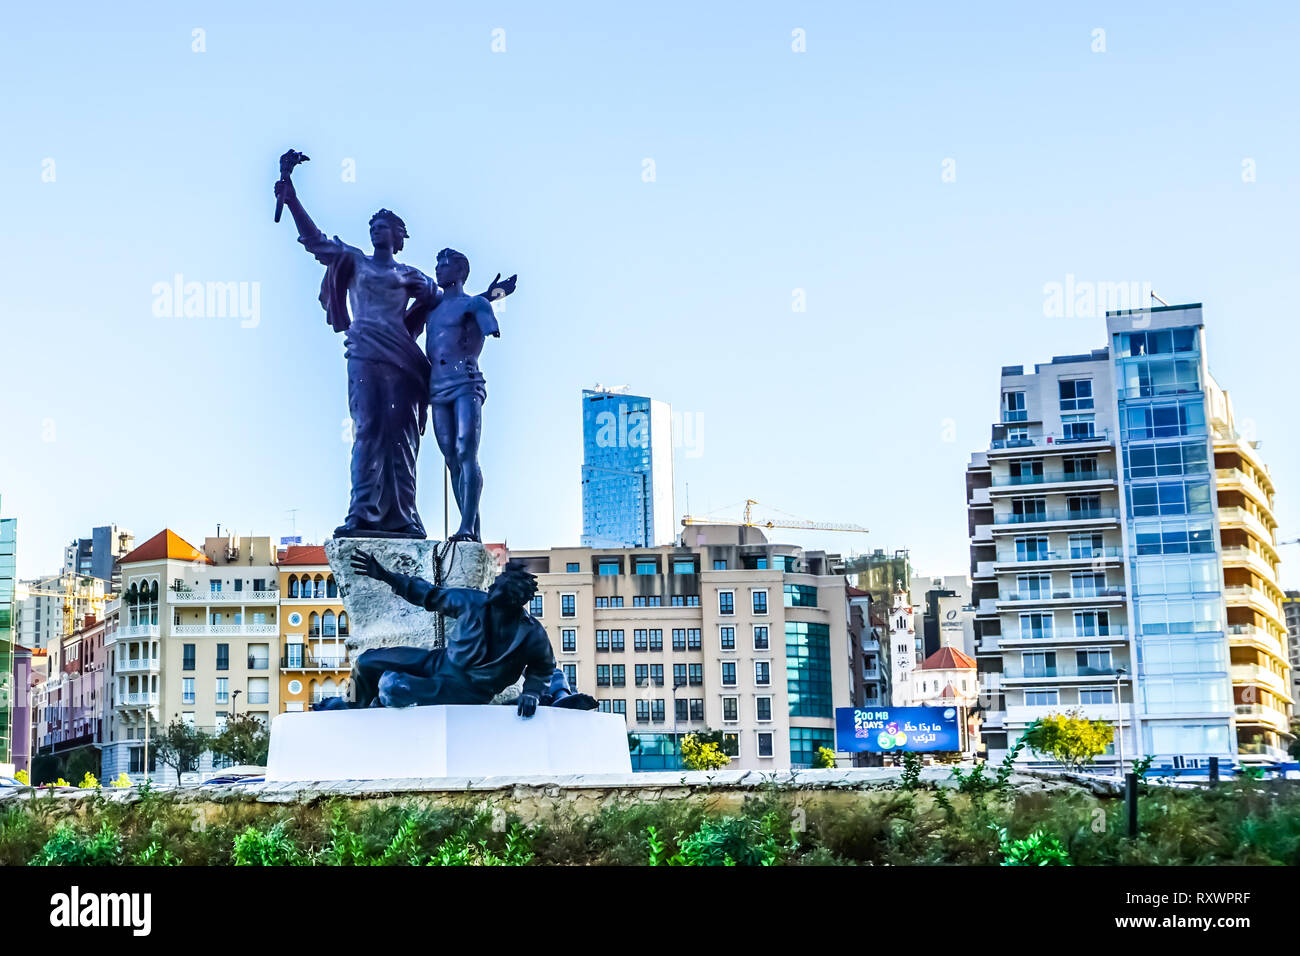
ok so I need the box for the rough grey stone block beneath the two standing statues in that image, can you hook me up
[325,537,497,661]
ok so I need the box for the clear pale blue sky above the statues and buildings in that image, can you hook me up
[0,0,1300,581]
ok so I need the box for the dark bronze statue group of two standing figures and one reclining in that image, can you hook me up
[276,150,597,717]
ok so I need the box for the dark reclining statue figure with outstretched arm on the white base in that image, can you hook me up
[320,549,597,717]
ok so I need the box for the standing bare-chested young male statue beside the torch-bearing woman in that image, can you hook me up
[408,248,515,541]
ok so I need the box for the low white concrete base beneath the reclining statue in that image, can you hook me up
[267,704,632,782]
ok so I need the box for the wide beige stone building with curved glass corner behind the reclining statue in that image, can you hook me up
[510,525,853,770]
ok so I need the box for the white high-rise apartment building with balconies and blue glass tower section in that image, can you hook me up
[967,304,1292,770]
